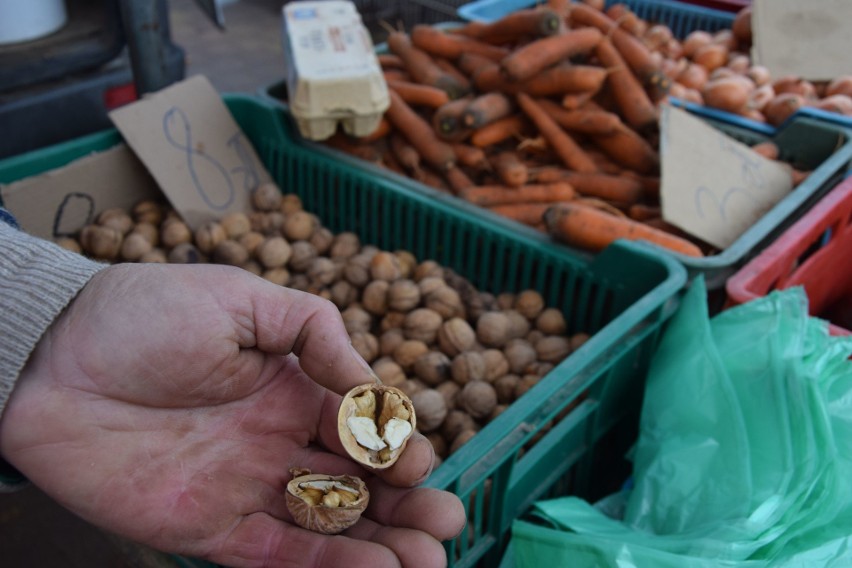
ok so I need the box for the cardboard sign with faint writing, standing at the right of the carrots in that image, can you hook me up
[660,105,793,249]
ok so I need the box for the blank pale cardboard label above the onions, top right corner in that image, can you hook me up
[751,0,852,81]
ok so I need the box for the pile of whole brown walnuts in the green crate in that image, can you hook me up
[58,184,588,466]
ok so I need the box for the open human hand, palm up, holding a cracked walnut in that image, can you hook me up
[0,264,464,568]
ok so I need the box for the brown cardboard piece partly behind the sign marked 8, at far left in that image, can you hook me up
[0,144,163,239]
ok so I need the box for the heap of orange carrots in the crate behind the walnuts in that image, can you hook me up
[318,0,804,256]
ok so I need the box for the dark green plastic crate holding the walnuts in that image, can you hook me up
[0,95,687,567]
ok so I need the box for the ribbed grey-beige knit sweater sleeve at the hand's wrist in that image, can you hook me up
[0,216,106,491]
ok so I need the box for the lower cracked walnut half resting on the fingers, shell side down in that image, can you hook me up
[286,468,370,534]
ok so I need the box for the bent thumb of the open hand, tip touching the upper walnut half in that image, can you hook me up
[251,281,378,395]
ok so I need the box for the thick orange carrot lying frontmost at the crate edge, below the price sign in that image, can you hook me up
[544,203,703,256]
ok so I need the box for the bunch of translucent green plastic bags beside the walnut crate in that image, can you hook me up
[512,278,852,568]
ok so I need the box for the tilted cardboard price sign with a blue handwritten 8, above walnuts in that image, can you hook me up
[110,75,271,229]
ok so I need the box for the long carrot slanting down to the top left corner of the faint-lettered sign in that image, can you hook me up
[591,37,657,130]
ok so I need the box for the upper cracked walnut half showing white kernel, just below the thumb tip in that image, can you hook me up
[337,384,417,469]
